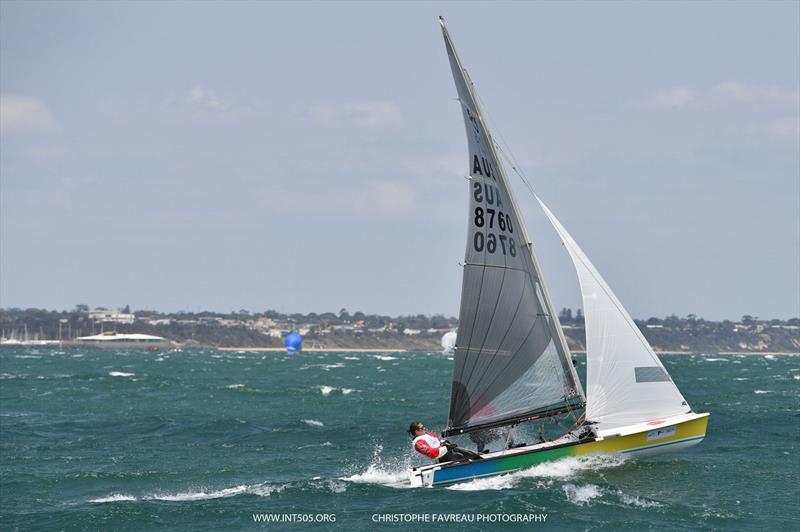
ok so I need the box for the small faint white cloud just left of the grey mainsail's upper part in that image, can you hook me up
[309,102,403,129]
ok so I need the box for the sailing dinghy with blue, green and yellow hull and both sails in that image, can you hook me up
[408,17,708,486]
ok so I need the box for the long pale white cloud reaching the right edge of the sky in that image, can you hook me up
[638,81,800,111]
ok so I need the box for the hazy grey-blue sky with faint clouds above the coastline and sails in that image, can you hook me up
[0,0,800,320]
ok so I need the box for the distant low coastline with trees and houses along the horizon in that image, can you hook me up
[0,304,800,352]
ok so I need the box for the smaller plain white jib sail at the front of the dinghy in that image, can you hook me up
[536,196,691,429]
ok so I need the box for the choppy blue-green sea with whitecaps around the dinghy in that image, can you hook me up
[0,349,800,530]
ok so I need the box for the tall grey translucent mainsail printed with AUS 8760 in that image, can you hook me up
[440,18,584,435]
